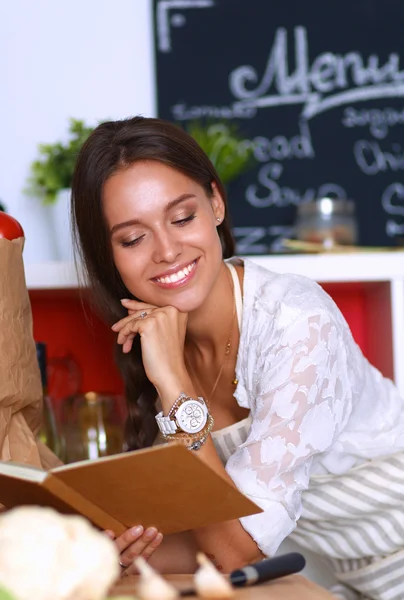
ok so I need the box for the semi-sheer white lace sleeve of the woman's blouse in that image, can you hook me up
[226,311,351,556]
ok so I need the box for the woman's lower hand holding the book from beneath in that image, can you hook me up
[104,525,163,575]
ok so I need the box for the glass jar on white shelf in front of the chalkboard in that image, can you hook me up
[295,198,358,248]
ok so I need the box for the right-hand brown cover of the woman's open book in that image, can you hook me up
[52,444,262,534]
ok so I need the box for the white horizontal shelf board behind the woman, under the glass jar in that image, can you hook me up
[25,251,404,290]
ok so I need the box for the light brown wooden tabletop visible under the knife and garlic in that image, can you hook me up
[111,575,335,600]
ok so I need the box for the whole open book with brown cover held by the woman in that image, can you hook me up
[0,444,262,535]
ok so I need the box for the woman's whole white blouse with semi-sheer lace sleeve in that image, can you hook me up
[226,259,404,556]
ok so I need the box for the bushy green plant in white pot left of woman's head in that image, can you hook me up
[26,119,93,204]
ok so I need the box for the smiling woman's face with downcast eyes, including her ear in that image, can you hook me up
[103,161,224,312]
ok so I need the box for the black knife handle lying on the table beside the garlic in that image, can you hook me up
[180,552,306,596]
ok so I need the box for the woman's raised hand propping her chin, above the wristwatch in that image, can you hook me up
[112,300,188,396]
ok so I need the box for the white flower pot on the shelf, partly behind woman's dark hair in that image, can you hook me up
[48,189,73,262]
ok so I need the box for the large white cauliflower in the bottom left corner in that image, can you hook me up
[0,506,119,600]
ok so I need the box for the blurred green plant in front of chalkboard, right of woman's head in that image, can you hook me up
[187,121,255,185]
